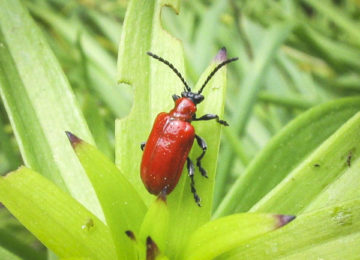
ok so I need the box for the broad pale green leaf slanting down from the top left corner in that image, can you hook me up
[0,0,102,217]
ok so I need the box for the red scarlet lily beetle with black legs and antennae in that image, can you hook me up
[140,48,238,206]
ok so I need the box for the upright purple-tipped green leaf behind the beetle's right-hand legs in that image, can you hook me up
[166,50,226,259]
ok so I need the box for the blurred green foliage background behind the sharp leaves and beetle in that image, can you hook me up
[0,0,360,256]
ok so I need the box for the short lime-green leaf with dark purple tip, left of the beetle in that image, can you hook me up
[67,132,146,259]
